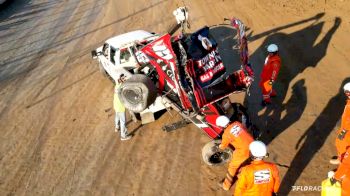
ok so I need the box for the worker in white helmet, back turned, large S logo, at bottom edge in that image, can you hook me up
[234,141,280,196]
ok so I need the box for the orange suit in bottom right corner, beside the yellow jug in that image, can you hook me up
[334,147,350,196]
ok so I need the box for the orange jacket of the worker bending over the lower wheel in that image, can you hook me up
[219,121,254,151]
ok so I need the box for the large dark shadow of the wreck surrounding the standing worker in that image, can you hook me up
[245,14,341,143]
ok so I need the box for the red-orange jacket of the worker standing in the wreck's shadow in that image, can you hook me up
[260,54,281,86]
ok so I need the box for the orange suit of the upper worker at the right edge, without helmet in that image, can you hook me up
[335,99,350,161]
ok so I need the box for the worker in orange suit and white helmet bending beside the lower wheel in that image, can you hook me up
[216,116,254,191]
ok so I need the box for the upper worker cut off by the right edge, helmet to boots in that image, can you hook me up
[330,82,350,165]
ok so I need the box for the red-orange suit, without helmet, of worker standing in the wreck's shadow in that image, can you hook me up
[259,54,281,102]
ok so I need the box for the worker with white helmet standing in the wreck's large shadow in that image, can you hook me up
[259,44,281,105]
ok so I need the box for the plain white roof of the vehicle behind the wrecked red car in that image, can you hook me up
[106,30,154,48]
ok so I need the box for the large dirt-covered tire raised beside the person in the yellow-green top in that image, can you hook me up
[118,74,157,113]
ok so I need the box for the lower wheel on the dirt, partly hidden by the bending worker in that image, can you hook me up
[202,140,232,166]
